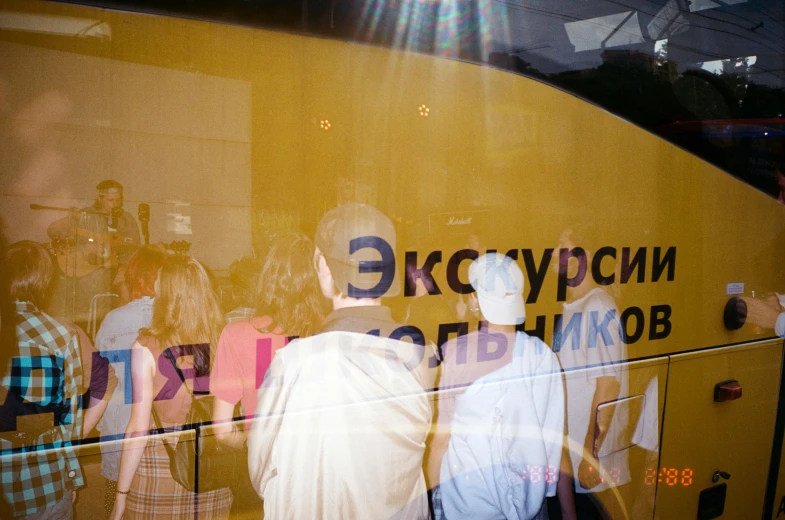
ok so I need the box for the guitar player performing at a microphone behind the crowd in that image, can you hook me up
[47,180,140,330]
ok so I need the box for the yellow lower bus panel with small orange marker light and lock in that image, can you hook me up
[656,340,782,518]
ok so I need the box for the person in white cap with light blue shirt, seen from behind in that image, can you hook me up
[428,253,564,520]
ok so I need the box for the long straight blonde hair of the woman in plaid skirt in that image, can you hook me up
[139,255,224,376]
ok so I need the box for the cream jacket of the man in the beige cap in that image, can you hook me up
[248,331,435,519]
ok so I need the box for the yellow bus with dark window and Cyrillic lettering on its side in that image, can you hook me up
[0,0,785,519]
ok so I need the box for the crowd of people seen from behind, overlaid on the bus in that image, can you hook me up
[0,182,660,520]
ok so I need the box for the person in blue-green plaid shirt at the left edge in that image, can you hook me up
[0,241,84,520]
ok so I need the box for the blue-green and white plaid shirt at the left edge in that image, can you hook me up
[0,302,84,517]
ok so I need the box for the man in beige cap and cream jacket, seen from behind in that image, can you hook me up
[248,203,435,519]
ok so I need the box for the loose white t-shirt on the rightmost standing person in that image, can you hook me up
[554,287,630,493]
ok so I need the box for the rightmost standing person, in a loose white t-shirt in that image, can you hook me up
[553,227,630,519]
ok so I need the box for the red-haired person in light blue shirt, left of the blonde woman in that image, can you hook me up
[95,246,166,516]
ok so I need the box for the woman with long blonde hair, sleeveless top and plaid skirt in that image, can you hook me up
[110,255,232,520]
